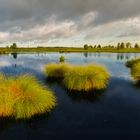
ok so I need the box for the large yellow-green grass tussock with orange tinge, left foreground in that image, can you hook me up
[0,75,56,119]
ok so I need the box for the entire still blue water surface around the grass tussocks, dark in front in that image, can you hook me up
[0,53,140,140]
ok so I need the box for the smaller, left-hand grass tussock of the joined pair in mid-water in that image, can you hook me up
[45,63,71,78]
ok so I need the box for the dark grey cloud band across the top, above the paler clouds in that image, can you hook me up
[0,0,140,26]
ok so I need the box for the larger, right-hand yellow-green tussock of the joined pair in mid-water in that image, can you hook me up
[63,65,109,91]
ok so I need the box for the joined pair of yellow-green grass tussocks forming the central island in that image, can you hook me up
[45,63,109,91]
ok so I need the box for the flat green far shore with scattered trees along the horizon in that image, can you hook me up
[0,42,140,55]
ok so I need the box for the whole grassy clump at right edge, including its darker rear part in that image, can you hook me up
[126,58,140,82]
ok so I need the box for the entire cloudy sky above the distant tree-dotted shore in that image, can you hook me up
[0,0,140,46]
